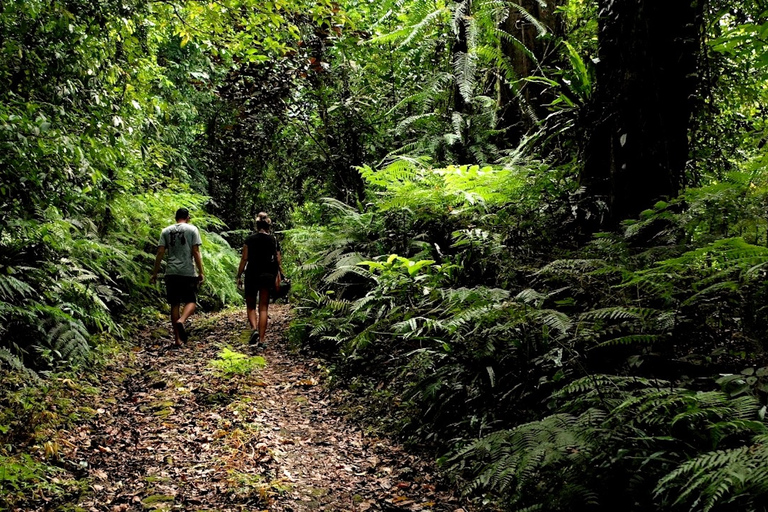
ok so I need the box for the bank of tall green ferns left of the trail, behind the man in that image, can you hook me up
[0,191,239,372]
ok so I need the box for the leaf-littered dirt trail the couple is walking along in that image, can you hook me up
[69,306,469,512]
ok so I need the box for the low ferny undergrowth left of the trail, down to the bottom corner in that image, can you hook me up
[0,191,241,508]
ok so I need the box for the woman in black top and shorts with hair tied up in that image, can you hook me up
[237,212,283,348]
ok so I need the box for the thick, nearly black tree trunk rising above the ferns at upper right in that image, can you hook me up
[581,0,702,230]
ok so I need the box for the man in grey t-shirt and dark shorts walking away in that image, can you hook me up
[149,208,204,347]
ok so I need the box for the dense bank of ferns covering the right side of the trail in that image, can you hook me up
[289,161,768,510]
